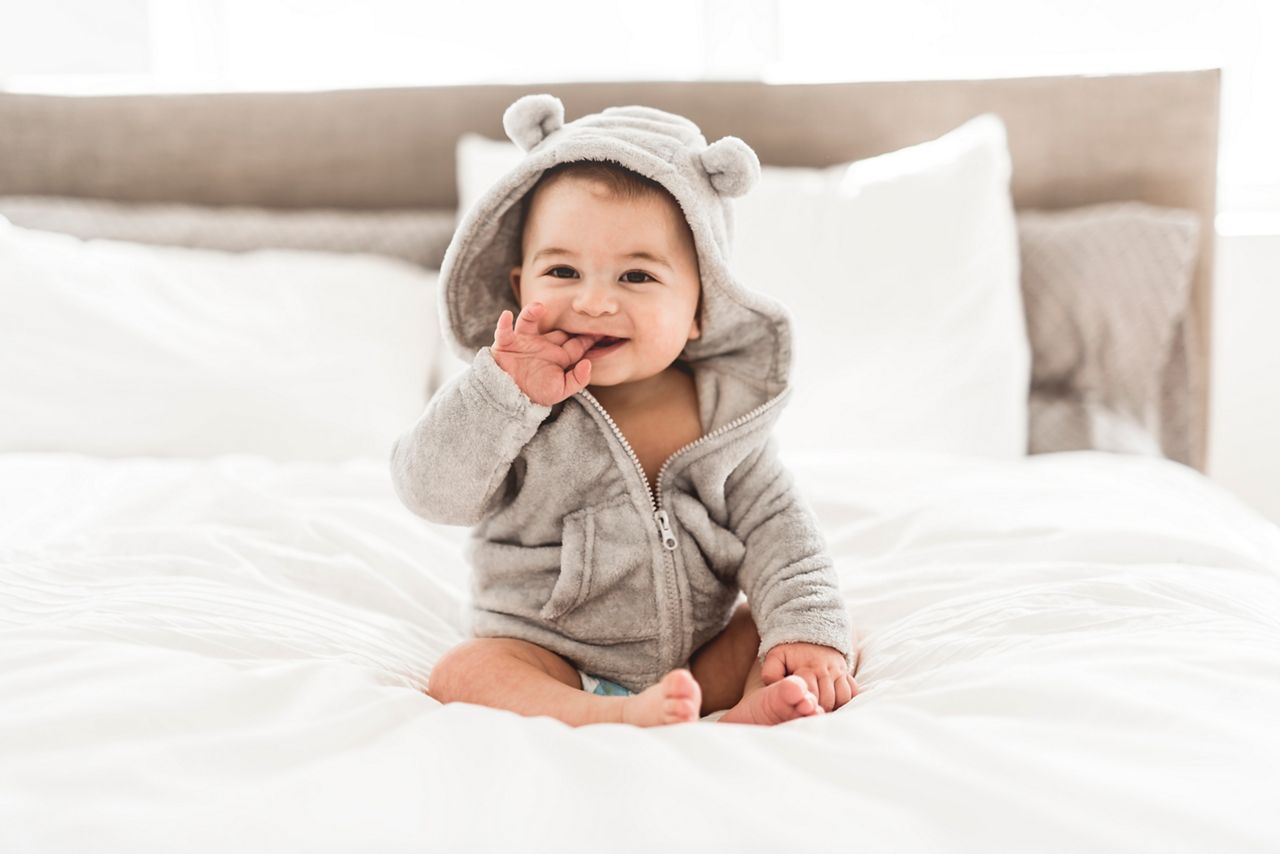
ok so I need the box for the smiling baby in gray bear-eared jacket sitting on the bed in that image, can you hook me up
[390,95,858,726]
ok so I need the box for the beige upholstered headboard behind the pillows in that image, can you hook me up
[0,69,1220,470]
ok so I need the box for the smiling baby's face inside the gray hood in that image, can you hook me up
[511,175,701,385]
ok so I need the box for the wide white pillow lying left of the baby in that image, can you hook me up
[0,223,439,461]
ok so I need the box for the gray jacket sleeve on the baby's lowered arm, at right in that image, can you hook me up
[727,437,854,668]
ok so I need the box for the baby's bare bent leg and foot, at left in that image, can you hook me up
[428,638,701,726]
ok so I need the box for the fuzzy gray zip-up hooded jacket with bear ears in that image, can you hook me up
[390,95,852,691]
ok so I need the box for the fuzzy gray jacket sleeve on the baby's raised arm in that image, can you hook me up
[390,347,552,525]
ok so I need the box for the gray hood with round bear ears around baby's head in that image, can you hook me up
[439,95,791,422]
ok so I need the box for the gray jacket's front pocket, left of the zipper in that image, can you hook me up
[540,495,658,643]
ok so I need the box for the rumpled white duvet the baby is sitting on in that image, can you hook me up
[0,452,1280,854]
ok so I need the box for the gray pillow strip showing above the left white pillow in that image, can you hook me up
[0,196,457,269]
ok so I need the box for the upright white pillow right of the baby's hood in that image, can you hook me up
[732,114,1030,458]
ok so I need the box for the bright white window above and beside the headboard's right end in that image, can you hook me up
[765,0,1280,213]
